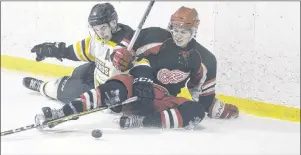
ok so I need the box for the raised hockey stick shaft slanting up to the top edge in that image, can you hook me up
[127,1,155,52]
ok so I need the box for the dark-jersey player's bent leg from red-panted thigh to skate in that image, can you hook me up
[119,88,205,129]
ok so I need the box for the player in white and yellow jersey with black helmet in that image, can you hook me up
[23,3,134,103]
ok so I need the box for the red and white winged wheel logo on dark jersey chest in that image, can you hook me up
[157,68,190,84]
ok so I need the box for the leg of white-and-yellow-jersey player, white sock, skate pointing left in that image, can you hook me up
[23,62,95,103]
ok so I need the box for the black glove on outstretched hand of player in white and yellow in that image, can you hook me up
[31,42,66,61]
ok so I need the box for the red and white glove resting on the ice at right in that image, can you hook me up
[208,99,239,119]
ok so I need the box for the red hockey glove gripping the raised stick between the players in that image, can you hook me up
[110,48,134,72]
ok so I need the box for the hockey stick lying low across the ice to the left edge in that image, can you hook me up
[1,96,138,136]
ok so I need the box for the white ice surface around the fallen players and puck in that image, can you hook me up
[1,69,300,155]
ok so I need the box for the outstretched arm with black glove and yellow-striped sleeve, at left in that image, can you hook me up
[31,37,95,62]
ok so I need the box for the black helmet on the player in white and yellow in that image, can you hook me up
[88,3,118,26]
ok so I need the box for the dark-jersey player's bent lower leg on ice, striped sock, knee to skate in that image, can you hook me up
[119,102,205,129]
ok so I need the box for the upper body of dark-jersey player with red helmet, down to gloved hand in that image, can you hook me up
[112,7,238,118]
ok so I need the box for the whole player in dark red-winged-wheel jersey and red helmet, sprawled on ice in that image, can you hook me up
[36,7,238,128]
